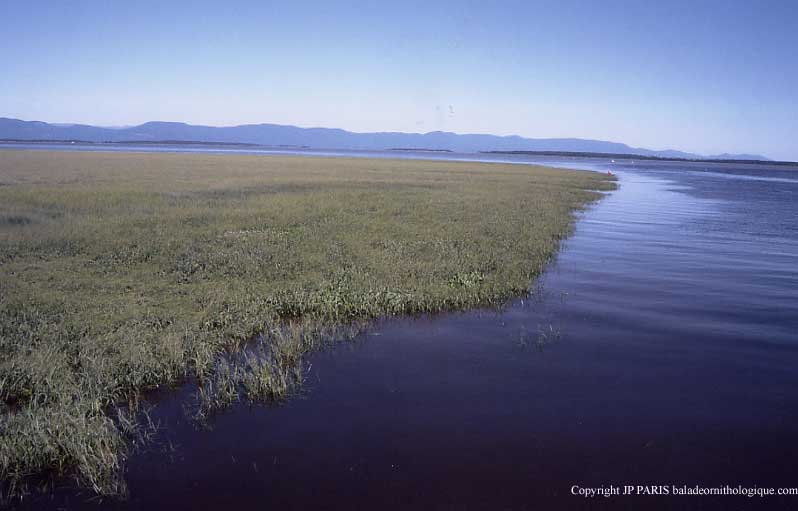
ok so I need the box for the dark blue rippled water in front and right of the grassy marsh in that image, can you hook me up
[12,147,798,510]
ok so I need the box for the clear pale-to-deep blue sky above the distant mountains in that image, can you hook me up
[0,0,798,160]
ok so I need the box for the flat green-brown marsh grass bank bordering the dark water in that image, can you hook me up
[0,151,614,500]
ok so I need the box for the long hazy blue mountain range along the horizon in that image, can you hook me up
[0,117,767,160]
